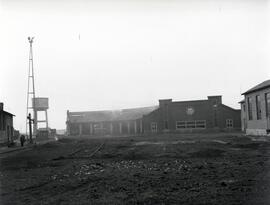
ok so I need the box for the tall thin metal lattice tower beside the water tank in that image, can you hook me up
[25,37,36,136]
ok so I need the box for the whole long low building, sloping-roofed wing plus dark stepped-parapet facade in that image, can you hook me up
[66,96,241,135]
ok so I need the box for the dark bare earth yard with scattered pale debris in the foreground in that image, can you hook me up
[0,134,270,205]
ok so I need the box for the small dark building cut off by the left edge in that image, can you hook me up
[0,103,15,143]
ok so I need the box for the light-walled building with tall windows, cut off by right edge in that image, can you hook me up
[240,80,270,135]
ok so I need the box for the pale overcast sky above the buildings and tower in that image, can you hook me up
[0,0,270,132]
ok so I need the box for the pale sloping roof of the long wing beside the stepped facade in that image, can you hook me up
[68,106,157,122]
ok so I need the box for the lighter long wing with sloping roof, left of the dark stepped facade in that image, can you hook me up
[66,107,156,135]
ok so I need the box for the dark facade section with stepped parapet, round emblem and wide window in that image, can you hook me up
[143,96,241,133]
